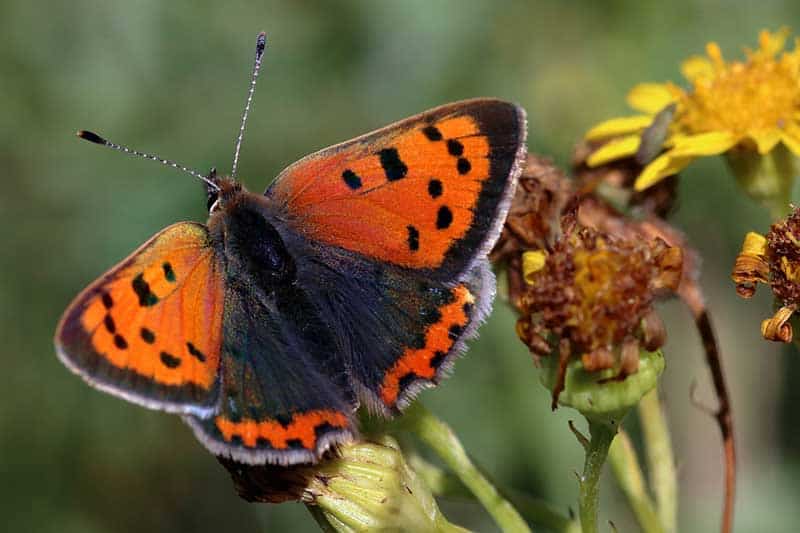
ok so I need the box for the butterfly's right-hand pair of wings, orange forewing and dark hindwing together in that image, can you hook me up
[266,99,526,413]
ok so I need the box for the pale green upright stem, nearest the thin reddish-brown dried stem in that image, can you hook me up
[639,389,678,533]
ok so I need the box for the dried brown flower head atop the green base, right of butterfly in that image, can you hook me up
[517,211,682,408]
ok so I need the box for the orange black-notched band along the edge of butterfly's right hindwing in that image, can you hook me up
[380,285,475,407]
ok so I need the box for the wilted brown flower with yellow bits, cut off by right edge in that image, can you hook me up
[731,208,800,342]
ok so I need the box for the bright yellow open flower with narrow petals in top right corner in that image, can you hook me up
[586,28,800,191]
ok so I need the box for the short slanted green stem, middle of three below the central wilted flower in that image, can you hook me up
[608,431,664,533]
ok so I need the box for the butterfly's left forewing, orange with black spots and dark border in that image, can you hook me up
[55,222,224,416]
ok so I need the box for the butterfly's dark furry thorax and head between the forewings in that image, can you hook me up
[208,189,296,294]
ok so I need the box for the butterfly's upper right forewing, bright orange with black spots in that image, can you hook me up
[266,99,526,279]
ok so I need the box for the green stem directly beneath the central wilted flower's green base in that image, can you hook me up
[579,419,617,533]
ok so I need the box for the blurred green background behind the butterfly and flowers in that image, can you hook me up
[0,0,800,532]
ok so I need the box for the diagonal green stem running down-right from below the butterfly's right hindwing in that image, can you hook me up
[400,402,531,532]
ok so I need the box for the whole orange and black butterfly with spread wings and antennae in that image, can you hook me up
[55,34,526,465]
